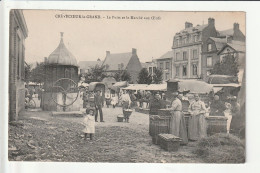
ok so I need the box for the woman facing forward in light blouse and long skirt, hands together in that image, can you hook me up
[188,94,207,140]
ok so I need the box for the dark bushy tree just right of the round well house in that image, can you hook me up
[84,65,107,83]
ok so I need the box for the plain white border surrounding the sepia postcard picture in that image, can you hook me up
[0,1,260,173]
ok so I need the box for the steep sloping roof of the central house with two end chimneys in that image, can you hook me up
[103,52,132,70]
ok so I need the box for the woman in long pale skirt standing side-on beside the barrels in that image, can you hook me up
[170,92,188,144]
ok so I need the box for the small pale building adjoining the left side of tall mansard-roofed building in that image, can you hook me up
[156,51,174,81]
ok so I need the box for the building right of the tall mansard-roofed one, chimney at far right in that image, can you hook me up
[202,23,245,80]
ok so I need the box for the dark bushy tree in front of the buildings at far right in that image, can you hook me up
[210,54,239,76]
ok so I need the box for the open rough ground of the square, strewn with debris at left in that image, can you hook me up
[8,107,202,163]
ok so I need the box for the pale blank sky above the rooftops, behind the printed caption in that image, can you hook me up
[23,10,246,63]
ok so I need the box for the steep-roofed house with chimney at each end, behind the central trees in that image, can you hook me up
[102,48,142,83]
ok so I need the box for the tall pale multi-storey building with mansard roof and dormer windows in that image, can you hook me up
[172,18,218,79]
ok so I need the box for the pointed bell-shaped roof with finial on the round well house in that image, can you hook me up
[46,33,78,66]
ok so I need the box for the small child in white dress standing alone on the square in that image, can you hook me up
[83,107,95,140]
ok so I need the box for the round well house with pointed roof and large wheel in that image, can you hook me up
[42,32,80,112]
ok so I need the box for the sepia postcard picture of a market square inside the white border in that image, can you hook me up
[8,9,247,164]
